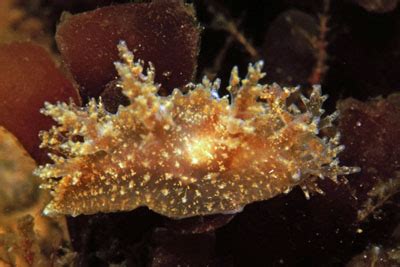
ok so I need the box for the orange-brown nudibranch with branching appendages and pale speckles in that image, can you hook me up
[36,41,358,218]
